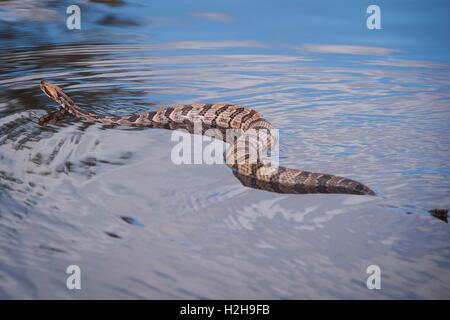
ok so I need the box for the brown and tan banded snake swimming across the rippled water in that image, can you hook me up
[41,81,375,195]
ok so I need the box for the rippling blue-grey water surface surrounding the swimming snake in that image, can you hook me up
[0,1,450,299]
